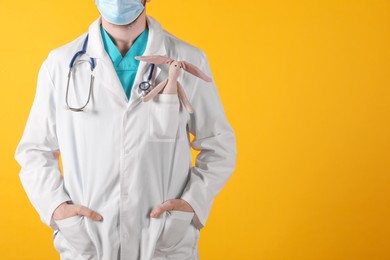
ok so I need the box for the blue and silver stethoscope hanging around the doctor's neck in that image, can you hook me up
[65,34,154,112]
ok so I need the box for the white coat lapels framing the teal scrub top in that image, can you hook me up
[87,15,167,105]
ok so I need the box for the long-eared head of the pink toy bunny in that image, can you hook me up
[135,55,212,82]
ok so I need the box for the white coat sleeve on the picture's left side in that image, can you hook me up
[14,56,71,229]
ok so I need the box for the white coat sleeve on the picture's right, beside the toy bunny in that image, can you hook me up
[181,51,236,229]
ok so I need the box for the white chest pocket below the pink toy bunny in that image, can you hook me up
[149,94,180,141]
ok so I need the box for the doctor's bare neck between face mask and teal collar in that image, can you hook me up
[102,11,147,56]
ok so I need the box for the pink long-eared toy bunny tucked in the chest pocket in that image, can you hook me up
[135,55,212,113]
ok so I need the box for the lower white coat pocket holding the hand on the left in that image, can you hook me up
[54,215,97,260]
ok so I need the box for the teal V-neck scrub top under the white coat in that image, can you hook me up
[100,25,149,100]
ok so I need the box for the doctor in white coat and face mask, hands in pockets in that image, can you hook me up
[15,0,236,260]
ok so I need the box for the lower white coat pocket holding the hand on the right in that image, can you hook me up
[156,210,194,249]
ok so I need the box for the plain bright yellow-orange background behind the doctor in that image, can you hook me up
[0,0,390,260]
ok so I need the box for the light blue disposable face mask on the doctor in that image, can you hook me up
[95,0,145,25]
